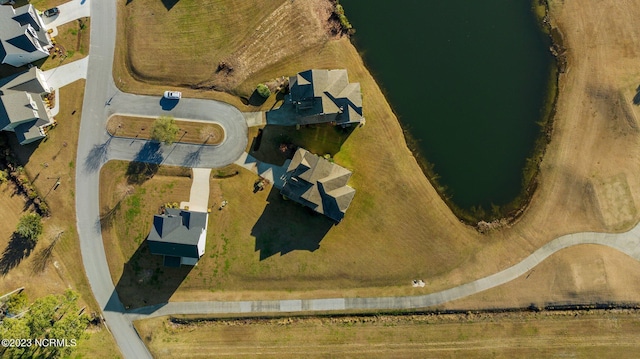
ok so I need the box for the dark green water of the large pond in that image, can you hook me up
[341,0,555,217]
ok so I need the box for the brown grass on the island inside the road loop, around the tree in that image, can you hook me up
[107,115,225,145]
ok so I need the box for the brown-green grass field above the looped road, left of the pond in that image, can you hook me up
[113,0,330,111]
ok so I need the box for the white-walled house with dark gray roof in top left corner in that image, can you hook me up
[0,4,53,67]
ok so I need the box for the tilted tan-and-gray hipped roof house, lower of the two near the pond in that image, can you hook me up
[280,148,356,222]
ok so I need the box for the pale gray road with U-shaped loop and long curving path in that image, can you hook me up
[76,0,640,358]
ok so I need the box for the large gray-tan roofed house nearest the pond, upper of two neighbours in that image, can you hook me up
[287,69,364,126]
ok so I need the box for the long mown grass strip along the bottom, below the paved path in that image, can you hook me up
[135,311,640,358]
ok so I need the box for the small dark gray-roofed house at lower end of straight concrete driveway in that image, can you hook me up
[147,208,209,267]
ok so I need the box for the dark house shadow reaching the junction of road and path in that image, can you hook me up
[116,240,193,309]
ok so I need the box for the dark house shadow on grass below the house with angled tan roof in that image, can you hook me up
[251,188,335,260]
